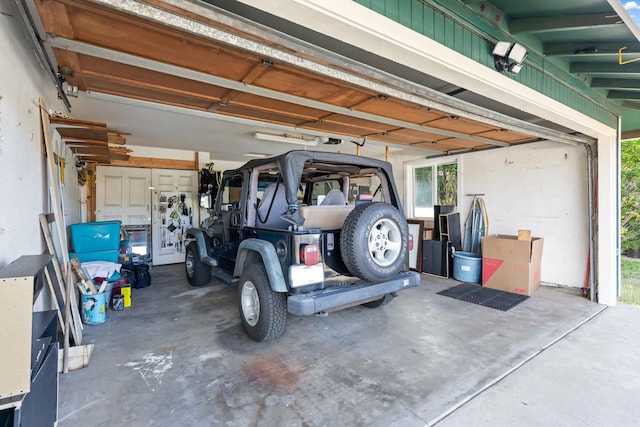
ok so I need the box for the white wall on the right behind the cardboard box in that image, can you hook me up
[460,142,589,287]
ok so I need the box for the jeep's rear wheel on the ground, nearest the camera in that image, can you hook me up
[238,263,287,342]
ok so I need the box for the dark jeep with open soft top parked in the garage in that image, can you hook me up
[185,150,420,341]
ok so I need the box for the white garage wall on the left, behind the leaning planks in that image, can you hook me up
[0,0,70,267]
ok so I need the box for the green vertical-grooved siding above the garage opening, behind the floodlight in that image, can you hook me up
[353,0,617,128]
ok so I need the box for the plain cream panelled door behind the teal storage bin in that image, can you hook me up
[96,166,151,225]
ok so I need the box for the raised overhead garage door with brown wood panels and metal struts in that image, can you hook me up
[34,0,592,155]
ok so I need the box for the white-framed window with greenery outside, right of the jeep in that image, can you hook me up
[408,160,458,218]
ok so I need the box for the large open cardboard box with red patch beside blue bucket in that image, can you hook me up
[482,234,544,295]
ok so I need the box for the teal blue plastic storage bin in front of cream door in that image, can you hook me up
[70,221,121,252]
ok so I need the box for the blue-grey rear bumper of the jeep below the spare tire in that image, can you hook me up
[287,271,420,316]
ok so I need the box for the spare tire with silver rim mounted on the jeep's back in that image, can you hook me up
[340,203,409,282]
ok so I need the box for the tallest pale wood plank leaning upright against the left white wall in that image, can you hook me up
[40,99,69,265]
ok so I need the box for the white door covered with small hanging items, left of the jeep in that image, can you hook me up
[151,169,199,265]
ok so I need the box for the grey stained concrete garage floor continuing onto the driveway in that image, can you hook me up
[58,264,640,427]
